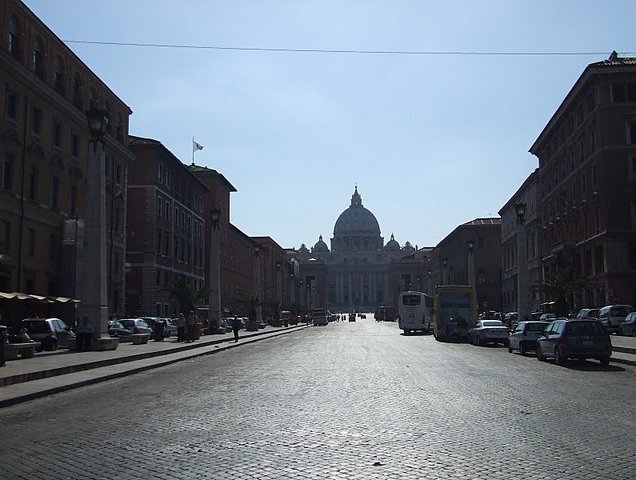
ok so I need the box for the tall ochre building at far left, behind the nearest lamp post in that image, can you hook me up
[0,0,132,322]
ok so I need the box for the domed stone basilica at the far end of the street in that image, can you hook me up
[292,187,432,312]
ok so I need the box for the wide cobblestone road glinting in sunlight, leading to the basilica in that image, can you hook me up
[0,319,636,480]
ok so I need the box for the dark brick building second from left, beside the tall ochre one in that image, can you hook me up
[125,136,208,317]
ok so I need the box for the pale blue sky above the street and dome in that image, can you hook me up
[24,0,636,248]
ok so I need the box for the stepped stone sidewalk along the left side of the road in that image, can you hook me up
[0,324,306,408]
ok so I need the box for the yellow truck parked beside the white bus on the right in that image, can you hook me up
[433,285,477,342]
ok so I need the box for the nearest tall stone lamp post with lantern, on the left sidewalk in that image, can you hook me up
[81,102,119,350]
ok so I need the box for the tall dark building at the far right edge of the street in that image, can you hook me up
[530,52,636,308]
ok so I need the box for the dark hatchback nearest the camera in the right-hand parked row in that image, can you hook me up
[537,318,612,365]
